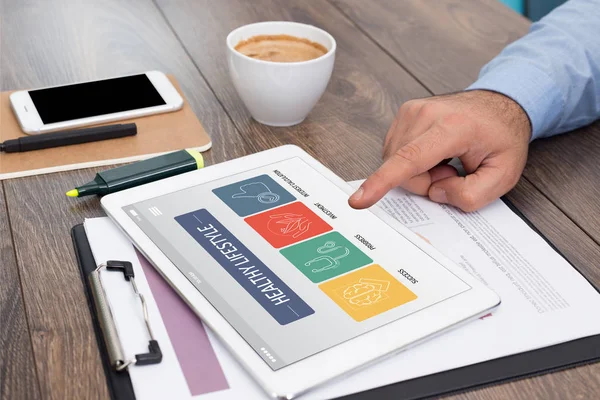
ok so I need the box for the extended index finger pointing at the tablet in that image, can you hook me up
[349,125,462,208]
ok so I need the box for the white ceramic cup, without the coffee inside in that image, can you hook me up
[227,21,336,126]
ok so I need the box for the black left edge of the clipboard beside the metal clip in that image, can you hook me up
[71,224,135,400]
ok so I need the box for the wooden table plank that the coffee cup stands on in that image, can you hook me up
[156,0,427,179]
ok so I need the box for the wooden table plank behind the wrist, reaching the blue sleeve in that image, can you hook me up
[332,0,530,94]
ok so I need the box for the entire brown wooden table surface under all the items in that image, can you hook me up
[0,0,600,399]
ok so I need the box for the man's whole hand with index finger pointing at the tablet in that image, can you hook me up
[349,90,531,211]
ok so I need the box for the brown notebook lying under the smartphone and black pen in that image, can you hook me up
[0,76,211,180]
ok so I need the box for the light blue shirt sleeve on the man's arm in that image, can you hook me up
[467,0,600,140]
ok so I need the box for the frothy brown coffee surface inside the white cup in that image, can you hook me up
[235,34,327,62]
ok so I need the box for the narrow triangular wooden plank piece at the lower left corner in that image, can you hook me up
[0,187,40,400]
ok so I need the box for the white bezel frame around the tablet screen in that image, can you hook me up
[101,145,500,398]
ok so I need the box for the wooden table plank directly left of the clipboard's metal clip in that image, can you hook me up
[4,170,108,399]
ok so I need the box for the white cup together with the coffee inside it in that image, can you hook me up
[226,21,336,126]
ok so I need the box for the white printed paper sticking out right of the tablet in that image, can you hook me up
[306,181,600,399]
